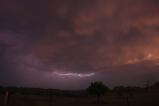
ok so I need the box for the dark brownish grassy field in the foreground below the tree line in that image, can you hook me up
[0,92,159,106]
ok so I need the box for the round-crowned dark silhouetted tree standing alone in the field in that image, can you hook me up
[86,82,109,103]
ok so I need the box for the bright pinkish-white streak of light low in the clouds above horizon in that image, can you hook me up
[53,72,95,78]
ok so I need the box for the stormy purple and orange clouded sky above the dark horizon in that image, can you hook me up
[0,0,159,89]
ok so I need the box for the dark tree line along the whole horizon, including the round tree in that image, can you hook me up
[0,81,159,103]
